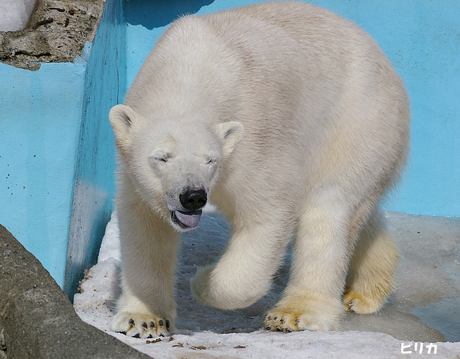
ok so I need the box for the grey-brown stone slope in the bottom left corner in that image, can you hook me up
[0,225,148,359]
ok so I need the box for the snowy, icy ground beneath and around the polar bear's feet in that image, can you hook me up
[74,208,460,359]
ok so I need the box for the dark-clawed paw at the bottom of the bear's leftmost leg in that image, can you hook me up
[111,312,176,339]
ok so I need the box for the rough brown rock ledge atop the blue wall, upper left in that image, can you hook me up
[0,0,105,71]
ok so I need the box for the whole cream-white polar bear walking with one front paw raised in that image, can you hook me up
[110,2,410,338]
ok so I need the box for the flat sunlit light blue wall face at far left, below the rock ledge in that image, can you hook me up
[0,61,86,285]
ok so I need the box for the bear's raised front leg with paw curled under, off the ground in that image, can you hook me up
[191,219,289,310]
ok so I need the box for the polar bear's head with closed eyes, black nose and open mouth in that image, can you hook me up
[110,105,244,231]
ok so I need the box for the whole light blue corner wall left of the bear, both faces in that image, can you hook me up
[0,0,126,295]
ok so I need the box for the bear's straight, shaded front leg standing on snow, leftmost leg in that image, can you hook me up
[111,190,178,338]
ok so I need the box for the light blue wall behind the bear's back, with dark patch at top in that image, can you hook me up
[126,0,460,216]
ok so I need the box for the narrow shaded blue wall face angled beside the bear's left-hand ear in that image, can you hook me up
[64,0,126,296]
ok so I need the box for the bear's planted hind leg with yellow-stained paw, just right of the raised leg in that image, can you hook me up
[264,192,362,331]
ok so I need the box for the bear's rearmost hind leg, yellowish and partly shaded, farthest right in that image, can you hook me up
[343,209,399,314]
